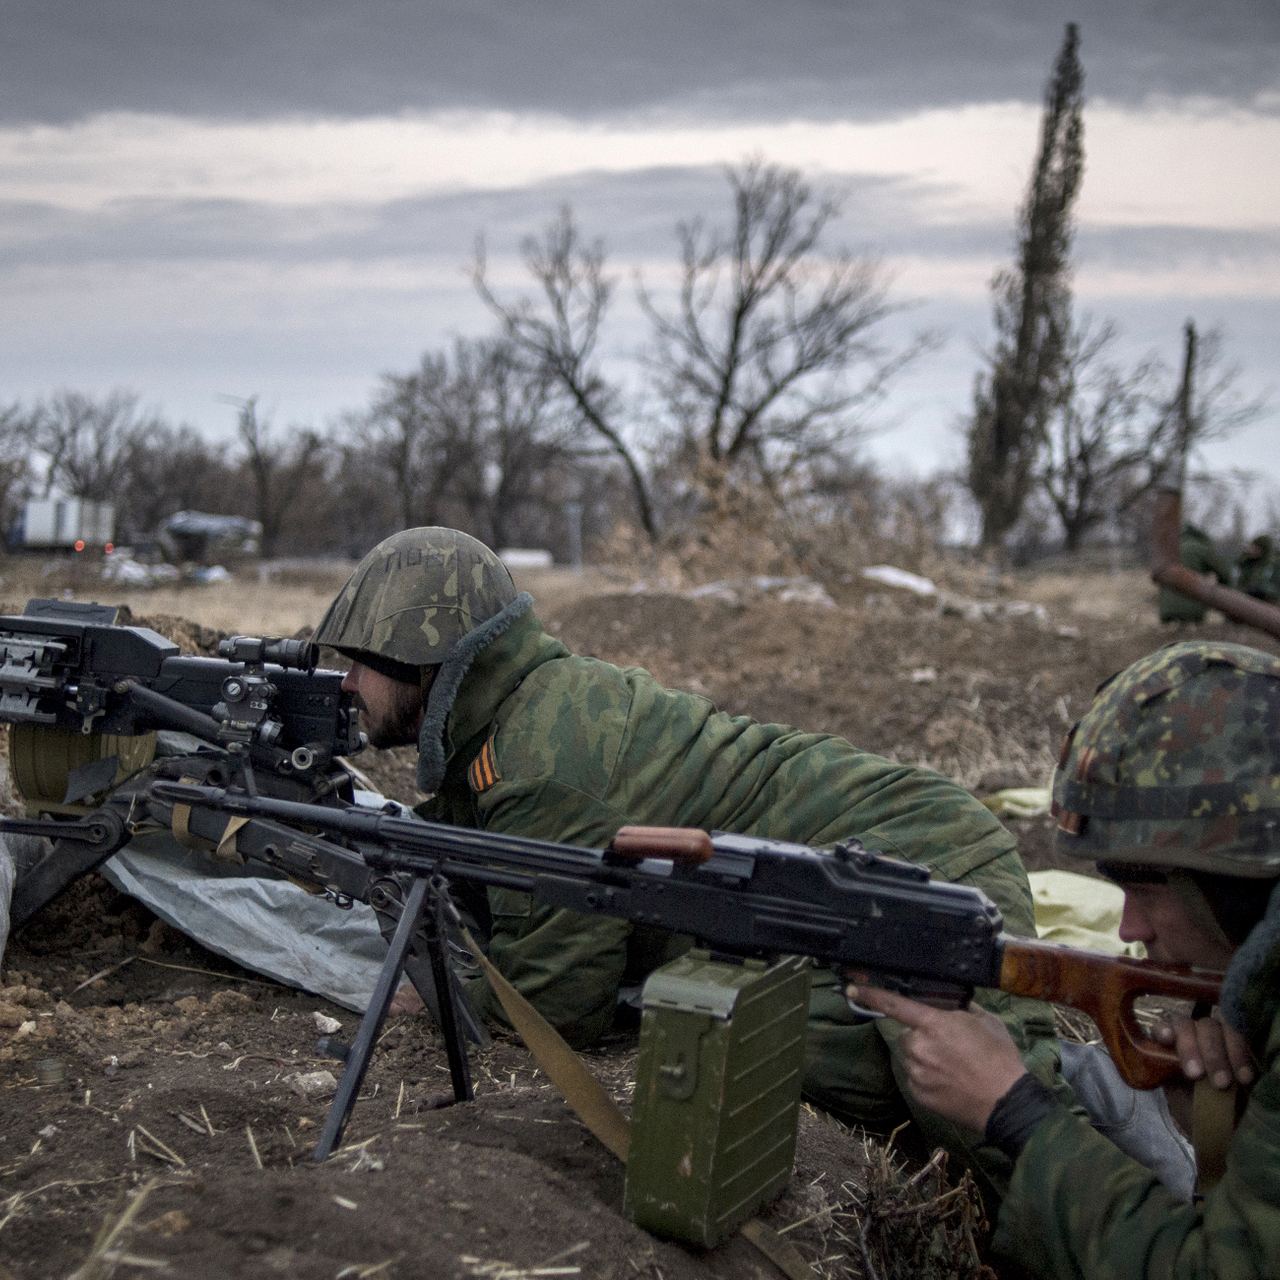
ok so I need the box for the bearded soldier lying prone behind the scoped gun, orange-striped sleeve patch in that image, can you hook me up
[312,529,1069,1202]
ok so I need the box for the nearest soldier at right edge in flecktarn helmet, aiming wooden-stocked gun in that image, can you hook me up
[858,643,1280,1277]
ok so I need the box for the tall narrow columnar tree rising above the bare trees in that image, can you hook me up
[966,23,1084,547]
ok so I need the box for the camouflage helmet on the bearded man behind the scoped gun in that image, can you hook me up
[311,529,516,682]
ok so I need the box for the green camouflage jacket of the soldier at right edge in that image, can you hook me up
[992,931,1280,1280]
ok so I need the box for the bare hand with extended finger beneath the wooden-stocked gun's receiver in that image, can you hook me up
[845,986,1027,1133]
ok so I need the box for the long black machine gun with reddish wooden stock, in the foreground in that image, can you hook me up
[151,782,1222,1089]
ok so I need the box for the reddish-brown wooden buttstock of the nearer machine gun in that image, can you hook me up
[1000,934,1222,1089]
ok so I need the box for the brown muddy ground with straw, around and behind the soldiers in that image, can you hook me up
[0,563,1280,1280]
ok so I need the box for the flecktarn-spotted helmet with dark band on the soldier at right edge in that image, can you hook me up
[1052,641,1280,878]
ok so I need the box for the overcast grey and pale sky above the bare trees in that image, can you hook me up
[0,0,1280,519]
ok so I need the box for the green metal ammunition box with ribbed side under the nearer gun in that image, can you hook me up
[623,951,809,1247]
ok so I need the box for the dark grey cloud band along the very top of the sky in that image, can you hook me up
[0,0,1280,122]
